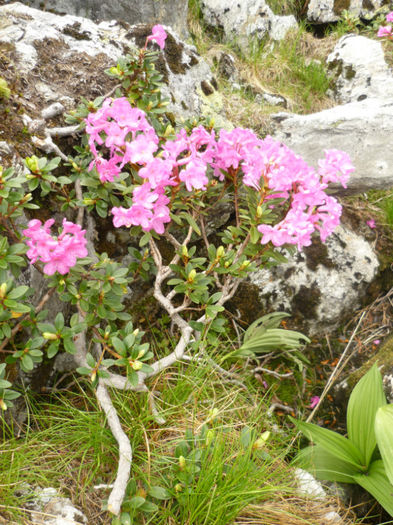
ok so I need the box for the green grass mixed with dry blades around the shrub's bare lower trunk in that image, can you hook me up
[0,356,294,525]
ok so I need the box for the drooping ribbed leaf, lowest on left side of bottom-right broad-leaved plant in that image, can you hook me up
[294,445,359,483]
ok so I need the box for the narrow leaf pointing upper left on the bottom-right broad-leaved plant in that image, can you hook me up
[289,416,365,473]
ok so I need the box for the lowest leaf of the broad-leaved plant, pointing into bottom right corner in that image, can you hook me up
[354,459,393,517]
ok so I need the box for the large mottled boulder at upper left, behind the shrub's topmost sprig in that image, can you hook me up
[0,2,224,130]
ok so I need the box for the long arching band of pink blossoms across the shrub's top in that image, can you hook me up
[86,98,354,249]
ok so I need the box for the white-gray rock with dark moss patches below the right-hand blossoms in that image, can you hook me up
[249,225,379,335]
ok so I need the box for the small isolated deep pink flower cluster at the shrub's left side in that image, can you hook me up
[23,219,87,275]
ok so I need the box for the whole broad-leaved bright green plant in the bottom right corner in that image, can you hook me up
[291,364,393,516]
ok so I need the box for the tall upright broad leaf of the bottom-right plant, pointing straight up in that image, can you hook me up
[347,364,386,467]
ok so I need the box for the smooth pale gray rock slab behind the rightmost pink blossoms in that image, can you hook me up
[272,98,393,194]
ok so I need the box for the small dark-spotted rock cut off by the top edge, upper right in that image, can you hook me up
[307,0,386,24]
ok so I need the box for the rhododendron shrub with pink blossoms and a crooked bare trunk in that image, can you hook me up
[0,25,354,514]
